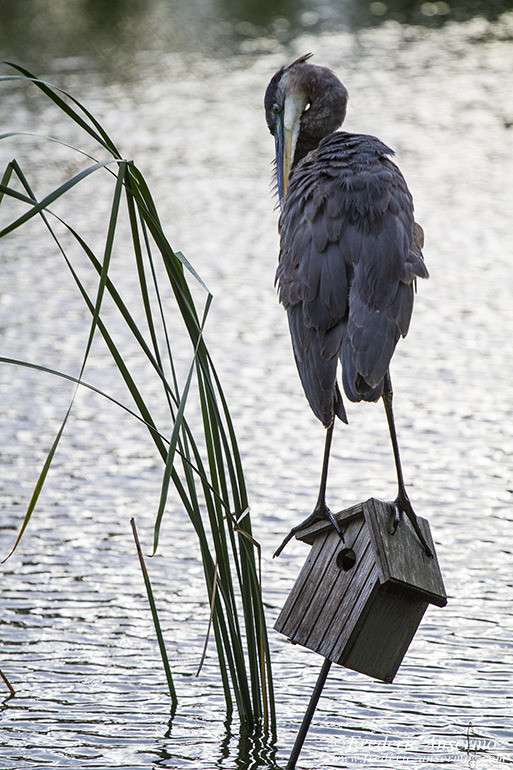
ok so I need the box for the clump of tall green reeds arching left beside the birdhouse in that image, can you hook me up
[0,65,275,730]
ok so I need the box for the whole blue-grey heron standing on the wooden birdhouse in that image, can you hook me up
[265,54,432,556]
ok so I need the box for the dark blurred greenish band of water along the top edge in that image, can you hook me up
[0,0,513,78]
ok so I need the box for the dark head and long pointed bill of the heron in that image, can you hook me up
[265,53,347,205]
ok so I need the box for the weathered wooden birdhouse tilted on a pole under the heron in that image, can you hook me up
[274,498,447,682]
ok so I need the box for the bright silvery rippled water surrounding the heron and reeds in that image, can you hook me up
[0,6,513,770]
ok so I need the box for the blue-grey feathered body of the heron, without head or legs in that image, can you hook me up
[276,132,428,426]
